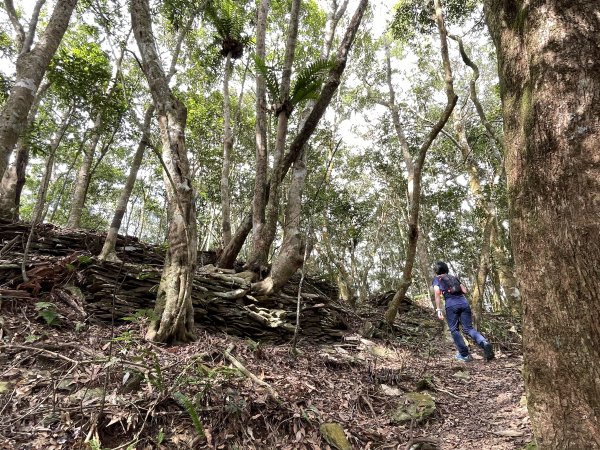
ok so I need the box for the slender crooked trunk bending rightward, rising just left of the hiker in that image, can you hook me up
[384,0,458,326]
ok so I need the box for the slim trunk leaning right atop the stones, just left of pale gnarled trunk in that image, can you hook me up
[98,106,154,261]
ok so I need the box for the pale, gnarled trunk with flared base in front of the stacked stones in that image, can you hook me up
[131,0,198,342]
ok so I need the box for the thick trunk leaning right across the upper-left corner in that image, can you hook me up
[0,0,77,179]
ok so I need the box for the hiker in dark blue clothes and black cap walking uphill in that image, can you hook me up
[431,261,494,362]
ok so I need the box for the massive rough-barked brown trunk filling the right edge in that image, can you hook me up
[486,0,600,450]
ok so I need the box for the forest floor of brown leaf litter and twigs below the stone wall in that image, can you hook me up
[0,294,531,450]
